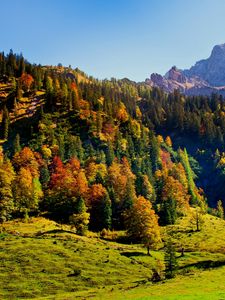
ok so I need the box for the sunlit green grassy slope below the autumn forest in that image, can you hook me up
[0,216,225,300]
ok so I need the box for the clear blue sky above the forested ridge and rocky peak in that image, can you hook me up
[0,0,225,81]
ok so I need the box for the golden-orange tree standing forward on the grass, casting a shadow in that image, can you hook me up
[125,196,161,255]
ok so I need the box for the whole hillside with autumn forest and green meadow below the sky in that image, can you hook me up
[0,51,225,299]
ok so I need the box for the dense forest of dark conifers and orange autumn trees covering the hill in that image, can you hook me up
[0,50,225,240]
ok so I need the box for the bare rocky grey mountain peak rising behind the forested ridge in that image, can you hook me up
[146,44,225,96]
